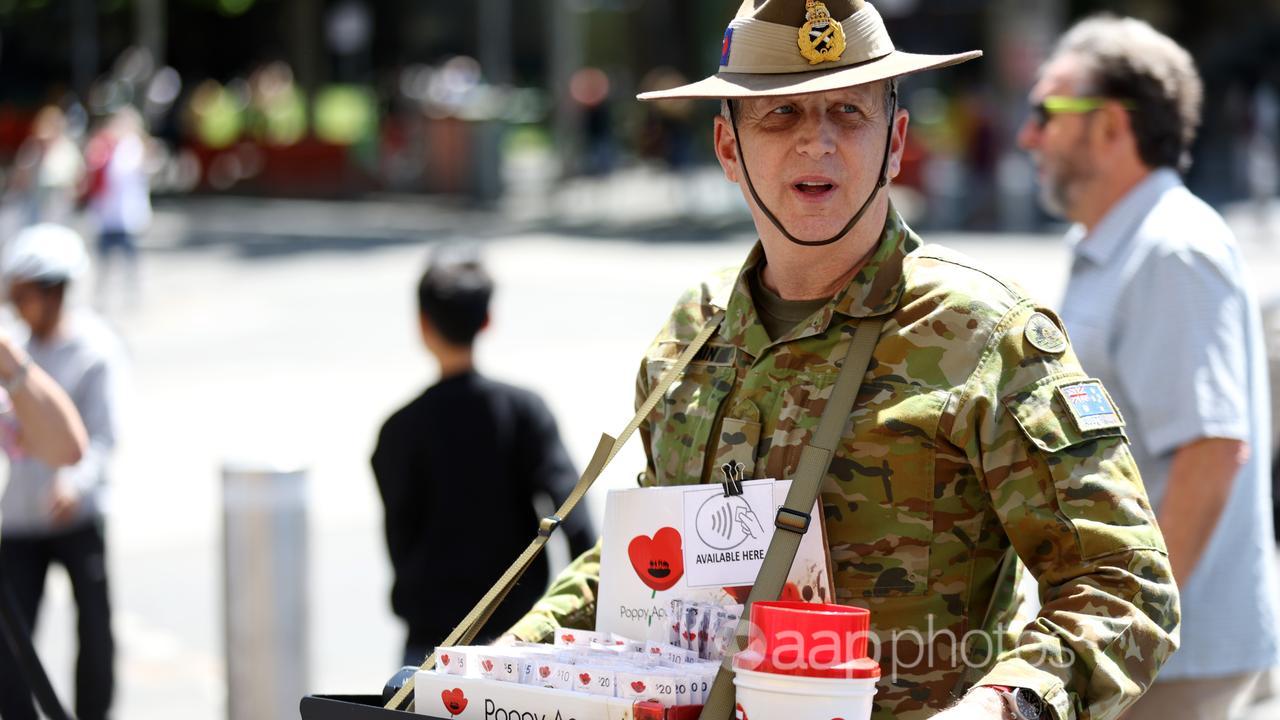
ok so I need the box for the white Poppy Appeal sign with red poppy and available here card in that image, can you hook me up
[595,480,832,642]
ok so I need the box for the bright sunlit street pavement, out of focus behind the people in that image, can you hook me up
[12,176,1280,720]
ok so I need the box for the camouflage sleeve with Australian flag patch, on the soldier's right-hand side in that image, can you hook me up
[952,301,1179,720]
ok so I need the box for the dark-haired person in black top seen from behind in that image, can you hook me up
[372,249,595,665]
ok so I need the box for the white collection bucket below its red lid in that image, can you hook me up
[733,667,876,720]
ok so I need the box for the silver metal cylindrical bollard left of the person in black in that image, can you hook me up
[223,462,307,720]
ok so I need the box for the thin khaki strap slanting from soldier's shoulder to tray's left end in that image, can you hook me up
[385,313,727,710]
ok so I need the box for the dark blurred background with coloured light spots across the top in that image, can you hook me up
[0,0,1280,229]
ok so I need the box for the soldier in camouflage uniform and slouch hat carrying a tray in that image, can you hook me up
[501,0,1179,720]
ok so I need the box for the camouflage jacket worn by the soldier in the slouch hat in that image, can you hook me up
[513,213,1179,720]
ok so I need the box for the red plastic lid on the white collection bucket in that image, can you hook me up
[733,601,881,678]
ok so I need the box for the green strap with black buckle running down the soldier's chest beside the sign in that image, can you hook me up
[699,319,884,720]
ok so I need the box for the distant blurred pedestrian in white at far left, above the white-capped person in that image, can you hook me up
[9,105,84,224]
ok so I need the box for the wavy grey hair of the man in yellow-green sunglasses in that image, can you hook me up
[1053,14,1204,172]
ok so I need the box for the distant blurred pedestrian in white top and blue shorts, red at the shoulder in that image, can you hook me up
[84,105,151,307]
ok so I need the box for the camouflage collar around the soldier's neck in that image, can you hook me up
[709,206,923,357]
